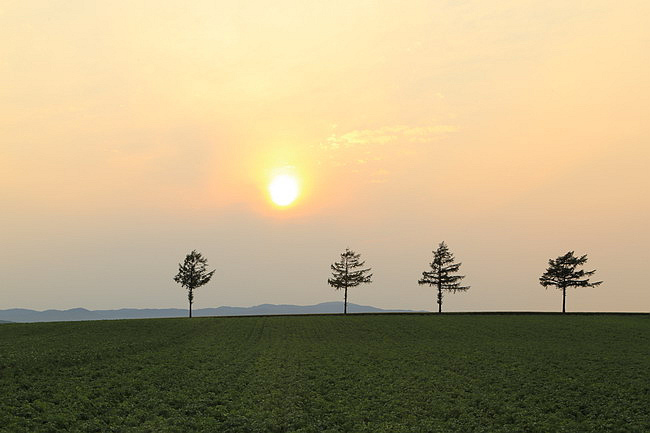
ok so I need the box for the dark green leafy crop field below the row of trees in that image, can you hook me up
[0,314,650,432]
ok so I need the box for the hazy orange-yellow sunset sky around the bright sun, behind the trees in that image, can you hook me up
[0,0,650,311]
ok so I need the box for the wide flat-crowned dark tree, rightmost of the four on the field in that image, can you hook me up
[539,251,603,313]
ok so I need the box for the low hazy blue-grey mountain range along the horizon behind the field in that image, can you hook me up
[0,302,410,323]
